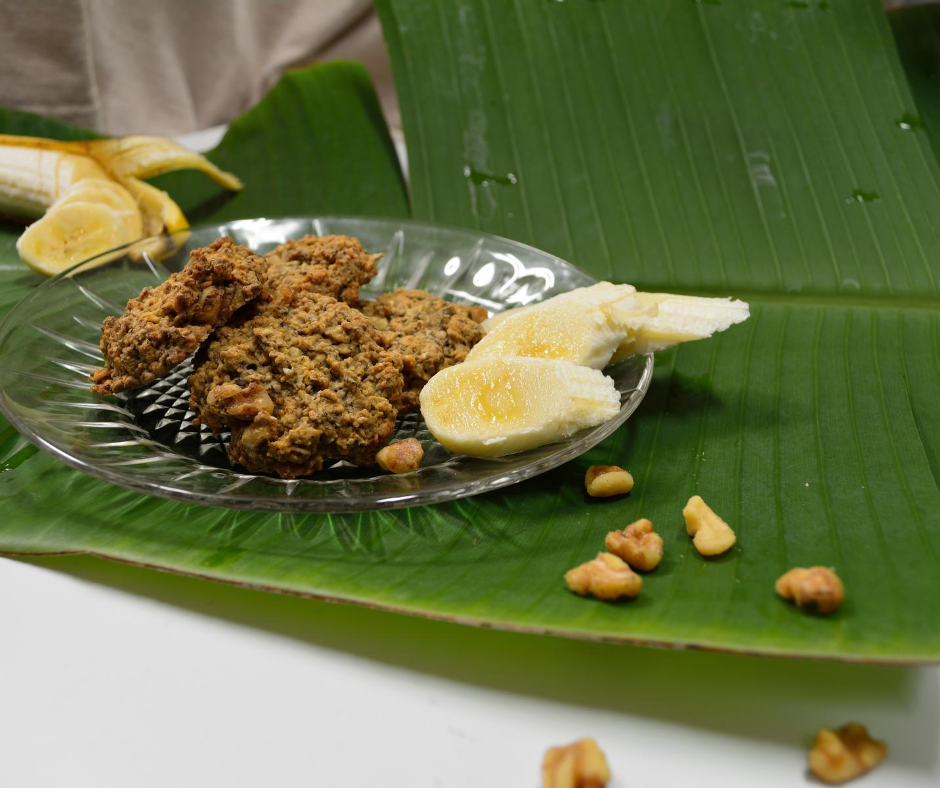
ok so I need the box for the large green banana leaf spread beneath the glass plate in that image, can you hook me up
[0,0,940,661]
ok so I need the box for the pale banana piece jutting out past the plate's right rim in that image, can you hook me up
[611,293,751,363]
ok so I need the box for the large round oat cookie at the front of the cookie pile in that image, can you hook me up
[190,288,403,479]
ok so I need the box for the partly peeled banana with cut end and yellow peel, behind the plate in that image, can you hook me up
[0,135,242,276]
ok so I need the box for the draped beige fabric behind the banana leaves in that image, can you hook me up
[0,0,397,135]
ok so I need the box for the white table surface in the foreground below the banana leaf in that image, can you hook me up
[0,130,940,788]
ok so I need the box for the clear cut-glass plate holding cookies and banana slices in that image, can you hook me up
[0,216,653,512]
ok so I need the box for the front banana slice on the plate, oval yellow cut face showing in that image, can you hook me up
[421,357,620,457]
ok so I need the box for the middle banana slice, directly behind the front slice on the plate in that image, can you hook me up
[467,282,646,369]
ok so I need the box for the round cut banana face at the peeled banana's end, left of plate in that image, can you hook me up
[16,202,141,276]
